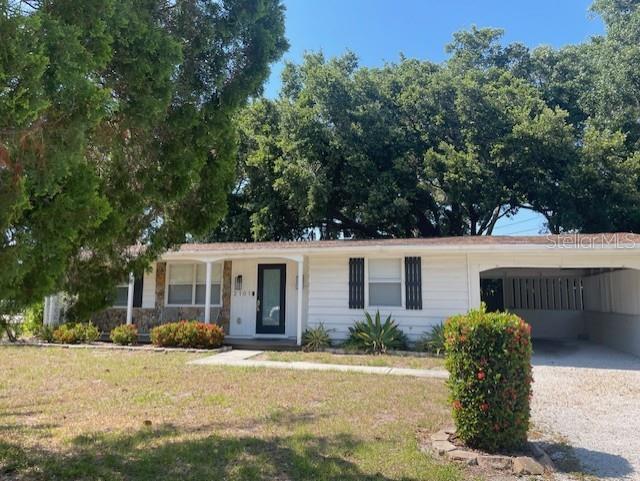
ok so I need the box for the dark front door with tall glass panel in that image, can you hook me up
[256,264,287,334]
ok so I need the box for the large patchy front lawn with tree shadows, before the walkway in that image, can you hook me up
[0,347,464,481]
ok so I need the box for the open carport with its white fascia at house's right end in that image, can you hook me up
[467,234,640,356]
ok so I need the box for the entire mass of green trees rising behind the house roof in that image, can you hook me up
[210,0,640,240]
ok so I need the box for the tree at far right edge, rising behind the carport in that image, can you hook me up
[529,0,640,232]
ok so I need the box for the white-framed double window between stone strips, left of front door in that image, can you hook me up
[167,263,222,306]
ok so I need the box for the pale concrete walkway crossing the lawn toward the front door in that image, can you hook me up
[189,350,449,379]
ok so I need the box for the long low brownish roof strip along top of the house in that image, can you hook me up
[176,232,640,252]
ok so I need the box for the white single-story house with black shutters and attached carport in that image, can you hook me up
[42,233,640,355]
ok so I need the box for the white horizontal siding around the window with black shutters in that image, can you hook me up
[308,253,469,341]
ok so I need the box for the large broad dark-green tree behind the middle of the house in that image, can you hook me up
[212,51,576,239]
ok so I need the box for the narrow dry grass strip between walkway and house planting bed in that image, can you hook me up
[252,351,444,369]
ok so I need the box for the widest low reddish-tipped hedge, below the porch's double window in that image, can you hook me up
[151,321,224,349]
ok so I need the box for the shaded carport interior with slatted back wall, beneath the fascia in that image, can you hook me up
[480,267,640,354]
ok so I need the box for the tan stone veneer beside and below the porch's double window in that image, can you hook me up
[91,261,231,333]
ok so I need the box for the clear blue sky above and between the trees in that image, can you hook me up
[265,0,604,235]
